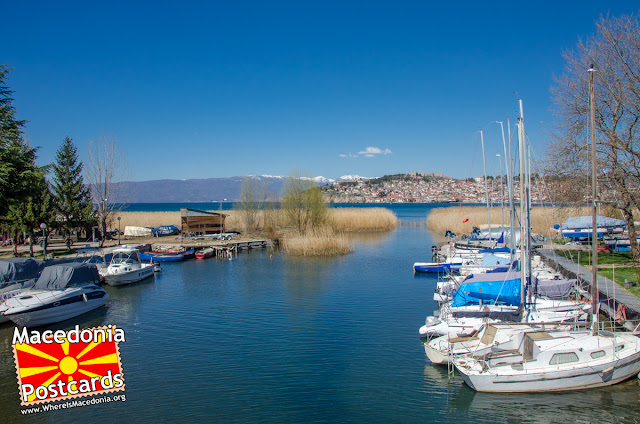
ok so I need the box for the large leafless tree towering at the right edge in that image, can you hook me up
[549,15,640,260]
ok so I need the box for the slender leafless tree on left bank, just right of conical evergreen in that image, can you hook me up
[85,136,127,245]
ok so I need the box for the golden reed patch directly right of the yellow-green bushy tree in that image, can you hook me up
[328,208,398,231]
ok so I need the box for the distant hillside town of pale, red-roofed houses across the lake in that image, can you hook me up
[322,172,549,203]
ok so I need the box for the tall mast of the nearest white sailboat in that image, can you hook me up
[589,65,598,322]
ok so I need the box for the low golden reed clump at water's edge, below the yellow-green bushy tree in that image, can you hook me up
[280,227,353,256]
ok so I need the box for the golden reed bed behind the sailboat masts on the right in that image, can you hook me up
[427,206,621,237]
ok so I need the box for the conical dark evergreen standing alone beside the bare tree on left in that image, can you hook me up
[52,137,93,235]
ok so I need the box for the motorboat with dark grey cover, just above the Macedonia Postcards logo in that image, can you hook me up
[0,262,109,327]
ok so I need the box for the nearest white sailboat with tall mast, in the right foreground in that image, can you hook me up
[453,94,640,393]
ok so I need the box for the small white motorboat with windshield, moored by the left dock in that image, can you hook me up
[100,245,155,286]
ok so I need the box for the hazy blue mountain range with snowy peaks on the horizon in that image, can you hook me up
[118,175,361,203]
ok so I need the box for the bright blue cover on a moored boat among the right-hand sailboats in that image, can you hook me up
[451,272,521,307]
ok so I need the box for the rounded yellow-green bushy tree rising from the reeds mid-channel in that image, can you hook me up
[281,171,327,233]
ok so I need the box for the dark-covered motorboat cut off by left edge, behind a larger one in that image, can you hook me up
[0,258,44,324]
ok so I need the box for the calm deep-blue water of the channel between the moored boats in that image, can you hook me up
[0,205,640,423]
